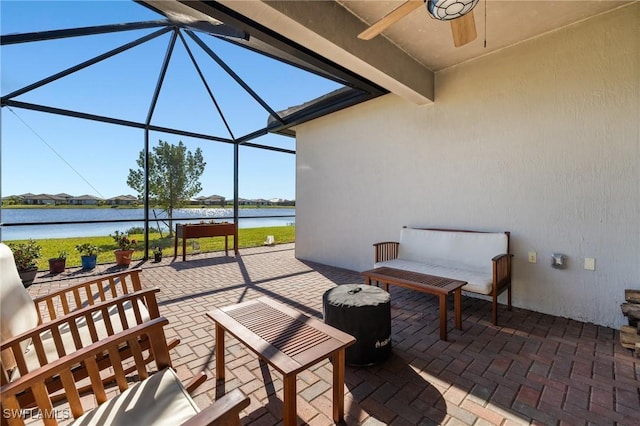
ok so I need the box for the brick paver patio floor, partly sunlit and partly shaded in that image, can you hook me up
[29,244,640,425]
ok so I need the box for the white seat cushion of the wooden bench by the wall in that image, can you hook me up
[374,259,493,294]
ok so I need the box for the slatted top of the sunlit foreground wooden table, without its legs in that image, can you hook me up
[207,297,355,374]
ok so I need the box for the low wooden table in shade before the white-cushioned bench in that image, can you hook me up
[362,267,467,340]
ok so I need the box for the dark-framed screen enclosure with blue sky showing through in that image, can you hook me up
[0,1,385,258]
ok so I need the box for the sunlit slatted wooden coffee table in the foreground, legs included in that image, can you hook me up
[207,297,355,426]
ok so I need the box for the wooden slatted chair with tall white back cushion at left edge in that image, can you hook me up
[0,243,179,402]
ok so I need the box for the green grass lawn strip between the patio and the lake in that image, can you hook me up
[5,226,296,270]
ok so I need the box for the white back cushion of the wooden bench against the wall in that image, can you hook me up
[398,228,509,273]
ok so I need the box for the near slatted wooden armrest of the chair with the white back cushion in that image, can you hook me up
[0,288,160,375]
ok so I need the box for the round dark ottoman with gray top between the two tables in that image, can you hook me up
[322,284,391,366]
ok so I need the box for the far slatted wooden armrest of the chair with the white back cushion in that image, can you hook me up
[33,268,142,322]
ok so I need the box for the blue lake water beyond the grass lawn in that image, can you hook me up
[0,208,296,241]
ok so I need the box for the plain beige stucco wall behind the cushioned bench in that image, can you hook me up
[296,4,640,327]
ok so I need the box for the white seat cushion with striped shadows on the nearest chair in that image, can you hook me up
[71,368,199,426]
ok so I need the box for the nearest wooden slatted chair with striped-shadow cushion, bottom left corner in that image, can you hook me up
[0,317,249,426]
